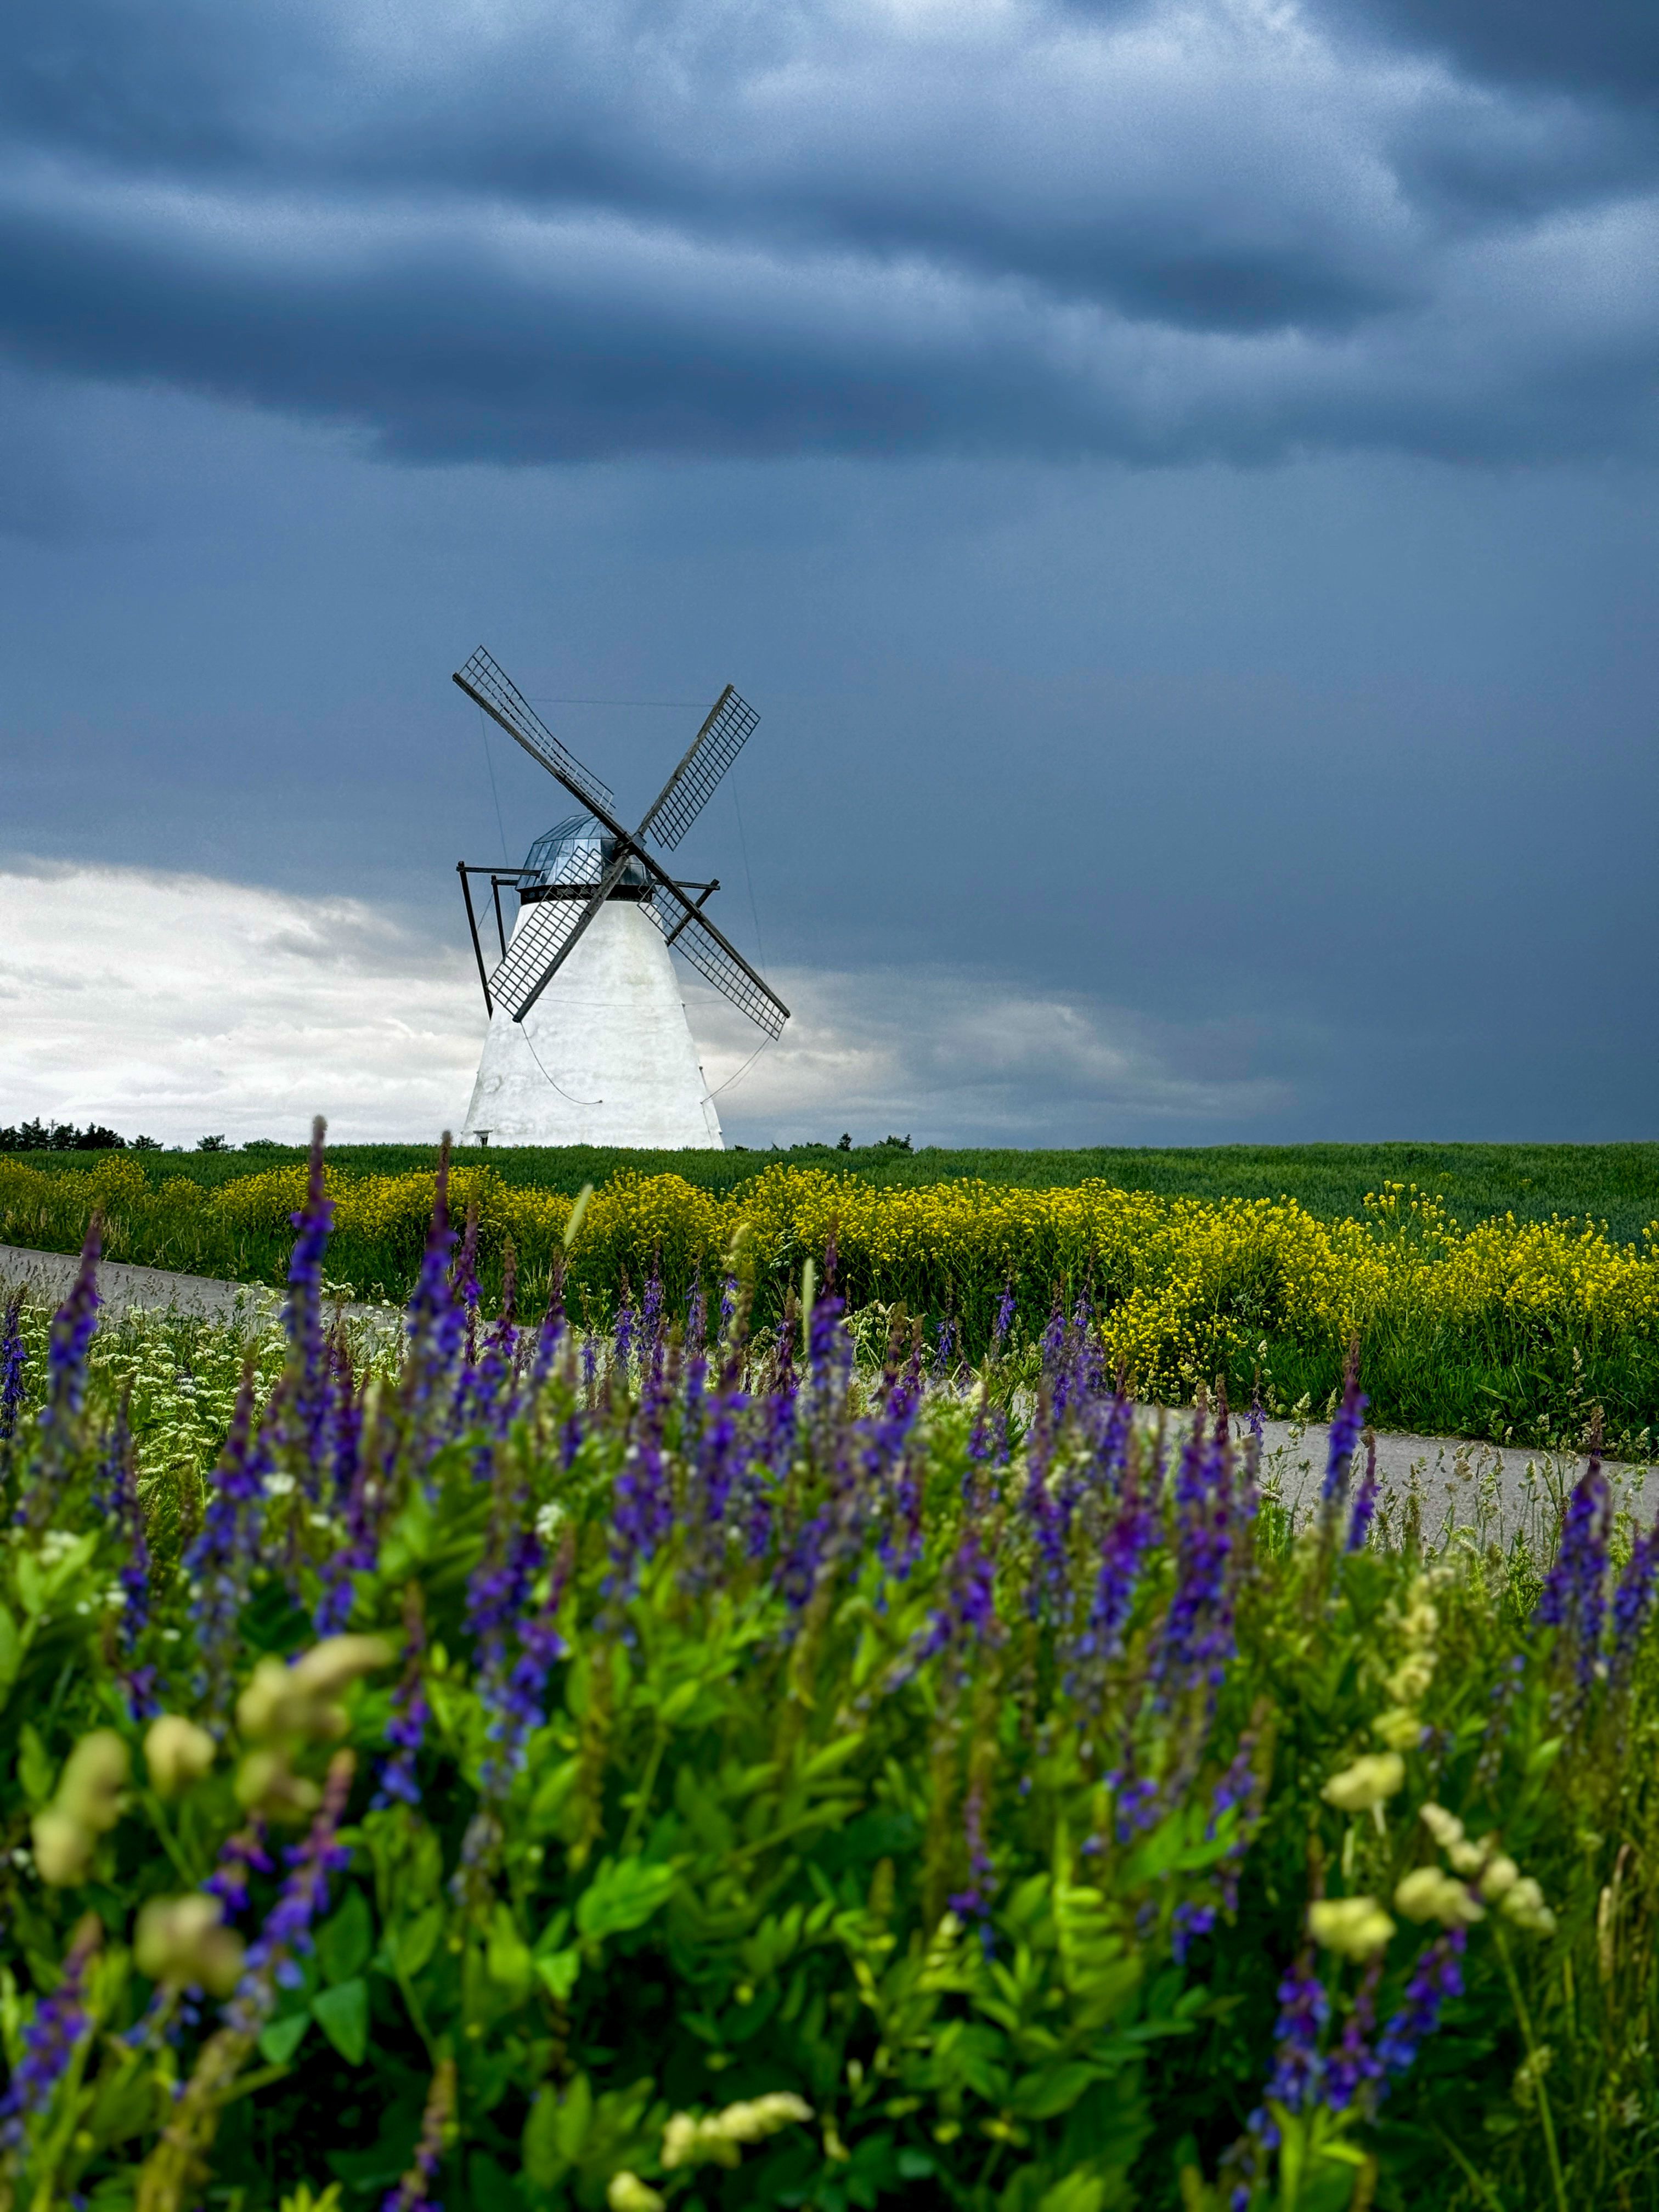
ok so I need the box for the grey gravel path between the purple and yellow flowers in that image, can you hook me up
[0,1245,1659,1548]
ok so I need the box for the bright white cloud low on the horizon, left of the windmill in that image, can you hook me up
[0,867,482,1144]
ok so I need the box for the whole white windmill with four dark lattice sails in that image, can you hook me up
[454,646,789,1148]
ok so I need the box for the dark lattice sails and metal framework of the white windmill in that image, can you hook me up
[454,646,789,1037]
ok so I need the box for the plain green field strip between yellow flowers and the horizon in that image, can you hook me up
[15,1144,1659,1243]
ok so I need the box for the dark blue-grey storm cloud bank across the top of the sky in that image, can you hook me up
[0,0,1659,460]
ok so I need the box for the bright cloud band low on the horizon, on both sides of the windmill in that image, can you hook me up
[0,865,1288,1144]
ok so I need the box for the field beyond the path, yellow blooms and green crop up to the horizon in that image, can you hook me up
[0,1146,1659,1458]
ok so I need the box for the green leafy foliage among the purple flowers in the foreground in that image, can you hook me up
[0,1265,1659,2212]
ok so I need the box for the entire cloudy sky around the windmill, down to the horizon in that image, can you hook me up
[0,13,1659,1144]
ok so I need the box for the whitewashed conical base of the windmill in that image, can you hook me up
[460,898,723,1153]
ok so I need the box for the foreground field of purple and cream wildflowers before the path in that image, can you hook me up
[0,1153,1659,2212]
